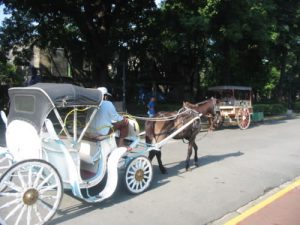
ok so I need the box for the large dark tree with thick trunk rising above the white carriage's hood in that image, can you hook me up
[1,0,155,84]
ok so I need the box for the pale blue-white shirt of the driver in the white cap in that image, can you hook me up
[88,100,123,135]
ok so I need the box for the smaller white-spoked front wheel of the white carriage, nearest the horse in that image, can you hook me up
[125,156,153,194]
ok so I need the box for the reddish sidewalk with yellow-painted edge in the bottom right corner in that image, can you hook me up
[224,179,300,225]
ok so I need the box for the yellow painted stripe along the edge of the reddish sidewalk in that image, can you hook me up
[224,179,300,225]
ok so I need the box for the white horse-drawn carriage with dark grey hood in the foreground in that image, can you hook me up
[0,83,200,225]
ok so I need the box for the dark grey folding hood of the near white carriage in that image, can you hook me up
[8,83,103,132]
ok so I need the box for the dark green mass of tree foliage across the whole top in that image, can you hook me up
[0,0,300,101]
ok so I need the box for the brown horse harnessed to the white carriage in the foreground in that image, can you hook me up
[145,99,216,173]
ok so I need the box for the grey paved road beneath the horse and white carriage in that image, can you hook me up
[0,118,300,225]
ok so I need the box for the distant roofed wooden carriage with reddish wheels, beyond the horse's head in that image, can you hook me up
[208,85,253,130]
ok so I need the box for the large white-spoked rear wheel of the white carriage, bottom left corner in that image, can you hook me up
[0,160,63,225]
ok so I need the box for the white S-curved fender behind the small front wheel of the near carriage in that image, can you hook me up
[95,147,127,202]
